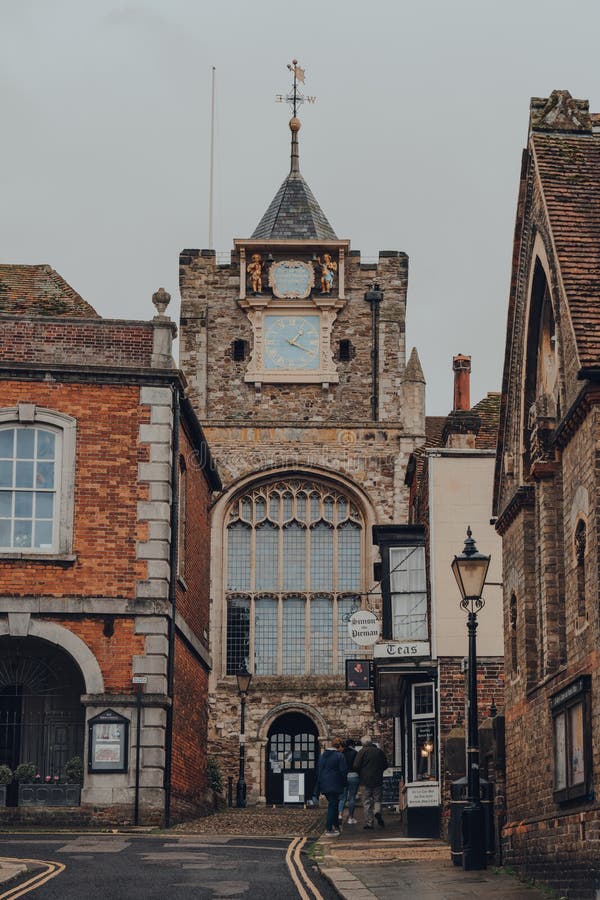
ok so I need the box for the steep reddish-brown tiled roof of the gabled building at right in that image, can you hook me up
[531,132,600,368]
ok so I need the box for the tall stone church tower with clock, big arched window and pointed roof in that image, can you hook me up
[180,96,425,803]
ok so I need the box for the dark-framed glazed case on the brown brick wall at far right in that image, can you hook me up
[550,675,592,803]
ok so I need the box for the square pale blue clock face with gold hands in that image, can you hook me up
[264,316,320,371]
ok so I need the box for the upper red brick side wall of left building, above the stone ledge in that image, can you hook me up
[177,429,211,647]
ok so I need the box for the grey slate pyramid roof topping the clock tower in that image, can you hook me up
[252,172,337,241]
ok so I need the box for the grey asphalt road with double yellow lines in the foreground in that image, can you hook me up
[0,834,338,900]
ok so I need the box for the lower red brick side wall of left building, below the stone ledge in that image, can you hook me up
[171,637,208,819]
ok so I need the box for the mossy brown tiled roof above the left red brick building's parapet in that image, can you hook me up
[0,265,100,319]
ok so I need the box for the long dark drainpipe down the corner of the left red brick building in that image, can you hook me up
[164,384,180,828]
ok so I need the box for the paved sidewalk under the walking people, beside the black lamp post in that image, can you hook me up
[316,810,549,900]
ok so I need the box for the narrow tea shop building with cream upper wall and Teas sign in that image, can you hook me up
[375,356,504,836]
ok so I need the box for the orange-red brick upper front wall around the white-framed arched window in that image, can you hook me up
[1,381,149,597]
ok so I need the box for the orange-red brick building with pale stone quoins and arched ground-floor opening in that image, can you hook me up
[0,265,220,821]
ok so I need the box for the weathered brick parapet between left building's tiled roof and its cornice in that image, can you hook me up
[0,318,154,367]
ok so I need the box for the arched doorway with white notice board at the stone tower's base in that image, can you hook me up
[265,712,319,804]
